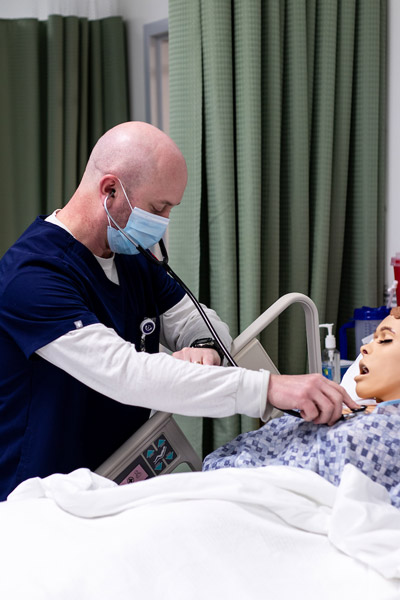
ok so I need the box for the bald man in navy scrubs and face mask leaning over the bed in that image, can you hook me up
[0,122,354,499]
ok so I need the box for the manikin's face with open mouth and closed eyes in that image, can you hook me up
[354,315,400,402]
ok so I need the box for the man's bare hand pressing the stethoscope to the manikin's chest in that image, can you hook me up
[268,373,359,425]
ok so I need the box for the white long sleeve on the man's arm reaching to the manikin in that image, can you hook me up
[37,323,269,420]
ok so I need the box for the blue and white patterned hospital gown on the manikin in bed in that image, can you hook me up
[203,400,400,508]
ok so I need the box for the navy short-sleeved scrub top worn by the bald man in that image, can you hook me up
[0,217,184,500]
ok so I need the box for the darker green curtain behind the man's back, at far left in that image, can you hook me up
[0,15,129,256]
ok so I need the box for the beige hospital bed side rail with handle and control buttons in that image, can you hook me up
[96,293,322,485]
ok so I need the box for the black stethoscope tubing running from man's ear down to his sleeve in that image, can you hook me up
[104,195,238,367]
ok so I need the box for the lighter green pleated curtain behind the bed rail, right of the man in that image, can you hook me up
[169,0,387,453]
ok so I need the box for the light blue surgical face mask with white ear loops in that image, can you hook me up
[104,182,169,254]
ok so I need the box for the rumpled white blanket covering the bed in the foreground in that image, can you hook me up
[0,465,400,600]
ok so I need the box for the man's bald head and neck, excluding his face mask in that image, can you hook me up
[57,121,187,257]
